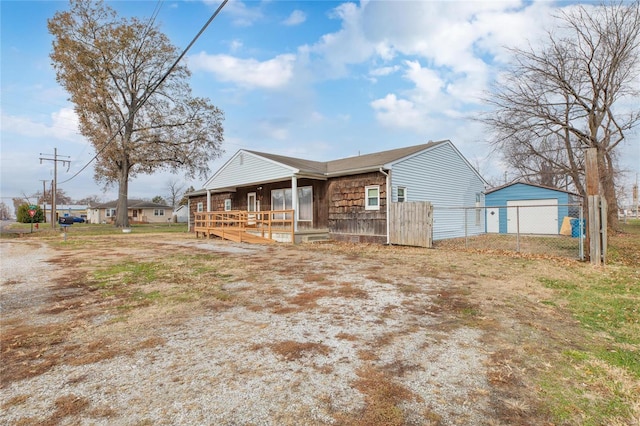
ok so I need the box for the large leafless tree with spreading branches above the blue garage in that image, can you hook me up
[482,0,640,226]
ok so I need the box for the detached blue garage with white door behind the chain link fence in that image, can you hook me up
[485,182,581,235]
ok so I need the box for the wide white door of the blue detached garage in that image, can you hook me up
[507,198,559,234]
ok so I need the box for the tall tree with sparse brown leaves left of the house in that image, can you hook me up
[48,0,223,227]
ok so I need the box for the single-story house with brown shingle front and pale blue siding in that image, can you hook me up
[188,140,488,243]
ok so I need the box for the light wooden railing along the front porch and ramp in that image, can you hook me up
[194,210,294,242]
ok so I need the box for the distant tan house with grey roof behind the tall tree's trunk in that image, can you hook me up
[87,200,173,223]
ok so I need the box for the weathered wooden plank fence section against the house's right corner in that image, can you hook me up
[389,201,433,248]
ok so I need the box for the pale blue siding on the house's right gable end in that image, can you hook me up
[391,142,485,240]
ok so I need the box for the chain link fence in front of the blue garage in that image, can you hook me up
[433,202,585,260]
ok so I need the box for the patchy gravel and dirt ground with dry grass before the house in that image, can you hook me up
[0,235,596,425]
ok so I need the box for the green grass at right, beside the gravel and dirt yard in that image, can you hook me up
[539,221,640,426]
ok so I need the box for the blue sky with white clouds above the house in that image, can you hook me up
[0,0,640,205]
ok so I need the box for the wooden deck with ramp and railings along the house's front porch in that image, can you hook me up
[194,210,295,244]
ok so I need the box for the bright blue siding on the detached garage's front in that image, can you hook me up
[485,182,571,234]
